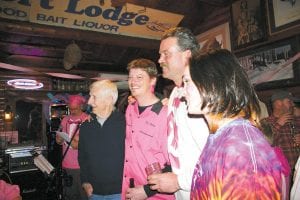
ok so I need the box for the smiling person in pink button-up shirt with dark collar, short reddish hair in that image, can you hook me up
[122,59,174,200]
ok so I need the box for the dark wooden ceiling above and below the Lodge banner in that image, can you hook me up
[0,0,232,79]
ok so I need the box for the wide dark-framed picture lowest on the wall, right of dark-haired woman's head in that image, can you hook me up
[237,38,300,86]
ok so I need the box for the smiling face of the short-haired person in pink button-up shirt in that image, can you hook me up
[128,68,155,98]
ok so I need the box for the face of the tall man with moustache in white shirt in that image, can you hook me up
[158,37,191,86]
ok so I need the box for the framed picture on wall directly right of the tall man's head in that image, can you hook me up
[197,22,231,50]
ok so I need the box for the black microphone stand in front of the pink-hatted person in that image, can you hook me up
[50,124,80,200]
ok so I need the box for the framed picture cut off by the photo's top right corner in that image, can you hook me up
[267,0,300,35]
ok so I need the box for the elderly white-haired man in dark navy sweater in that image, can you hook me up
[78,80,125,200]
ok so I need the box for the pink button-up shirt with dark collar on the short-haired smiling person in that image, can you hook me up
[122,102,174,199]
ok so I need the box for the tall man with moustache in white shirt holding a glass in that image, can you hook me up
[148,27,209,200]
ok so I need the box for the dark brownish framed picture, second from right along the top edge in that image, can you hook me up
[231,0,266,49]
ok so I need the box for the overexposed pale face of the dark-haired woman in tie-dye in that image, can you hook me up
[182,68,203,114]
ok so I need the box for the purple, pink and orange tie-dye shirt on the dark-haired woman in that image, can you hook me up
[191,119,285,200]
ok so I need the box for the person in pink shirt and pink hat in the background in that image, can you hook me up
[56,95,88,200]
